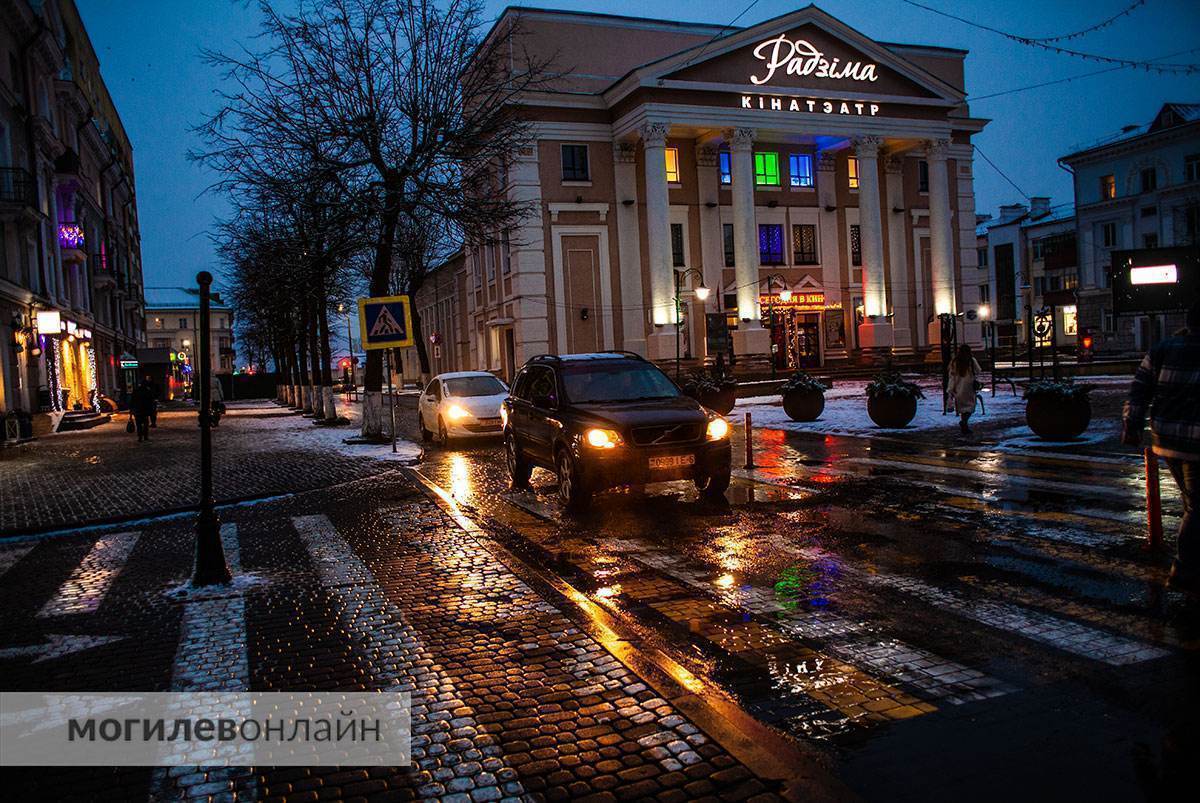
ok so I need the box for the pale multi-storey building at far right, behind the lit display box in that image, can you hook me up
[1058,103,1200,354]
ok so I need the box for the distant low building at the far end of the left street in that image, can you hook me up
[146,287,238,380]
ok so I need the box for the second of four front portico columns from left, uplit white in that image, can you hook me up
[726,128,770,355]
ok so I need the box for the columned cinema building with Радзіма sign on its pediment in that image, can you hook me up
[446,6,986,376]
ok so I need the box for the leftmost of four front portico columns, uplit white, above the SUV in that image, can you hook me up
[642,122,676,360]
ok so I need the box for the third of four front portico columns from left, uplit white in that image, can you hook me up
[854,137,893,353]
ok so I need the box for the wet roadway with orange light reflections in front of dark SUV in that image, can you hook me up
[410,422,1200,799]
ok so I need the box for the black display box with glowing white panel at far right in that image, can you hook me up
[1110,247,1200,314]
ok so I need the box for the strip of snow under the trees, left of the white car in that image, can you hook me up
[227,398,421,465]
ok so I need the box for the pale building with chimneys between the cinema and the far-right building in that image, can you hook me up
[976,197,1079,352]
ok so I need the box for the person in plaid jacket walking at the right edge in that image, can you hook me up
[1121,301,1200,593]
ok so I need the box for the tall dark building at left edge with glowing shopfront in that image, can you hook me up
[0,0,144,413]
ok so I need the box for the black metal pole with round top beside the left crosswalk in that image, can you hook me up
[192,270,232,587]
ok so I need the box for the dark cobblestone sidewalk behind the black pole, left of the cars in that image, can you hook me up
[0,402,403,534]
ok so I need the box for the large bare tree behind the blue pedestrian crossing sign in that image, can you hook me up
[202,0,548,437]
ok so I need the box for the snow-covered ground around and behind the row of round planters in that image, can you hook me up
[731,377,1129,445]
